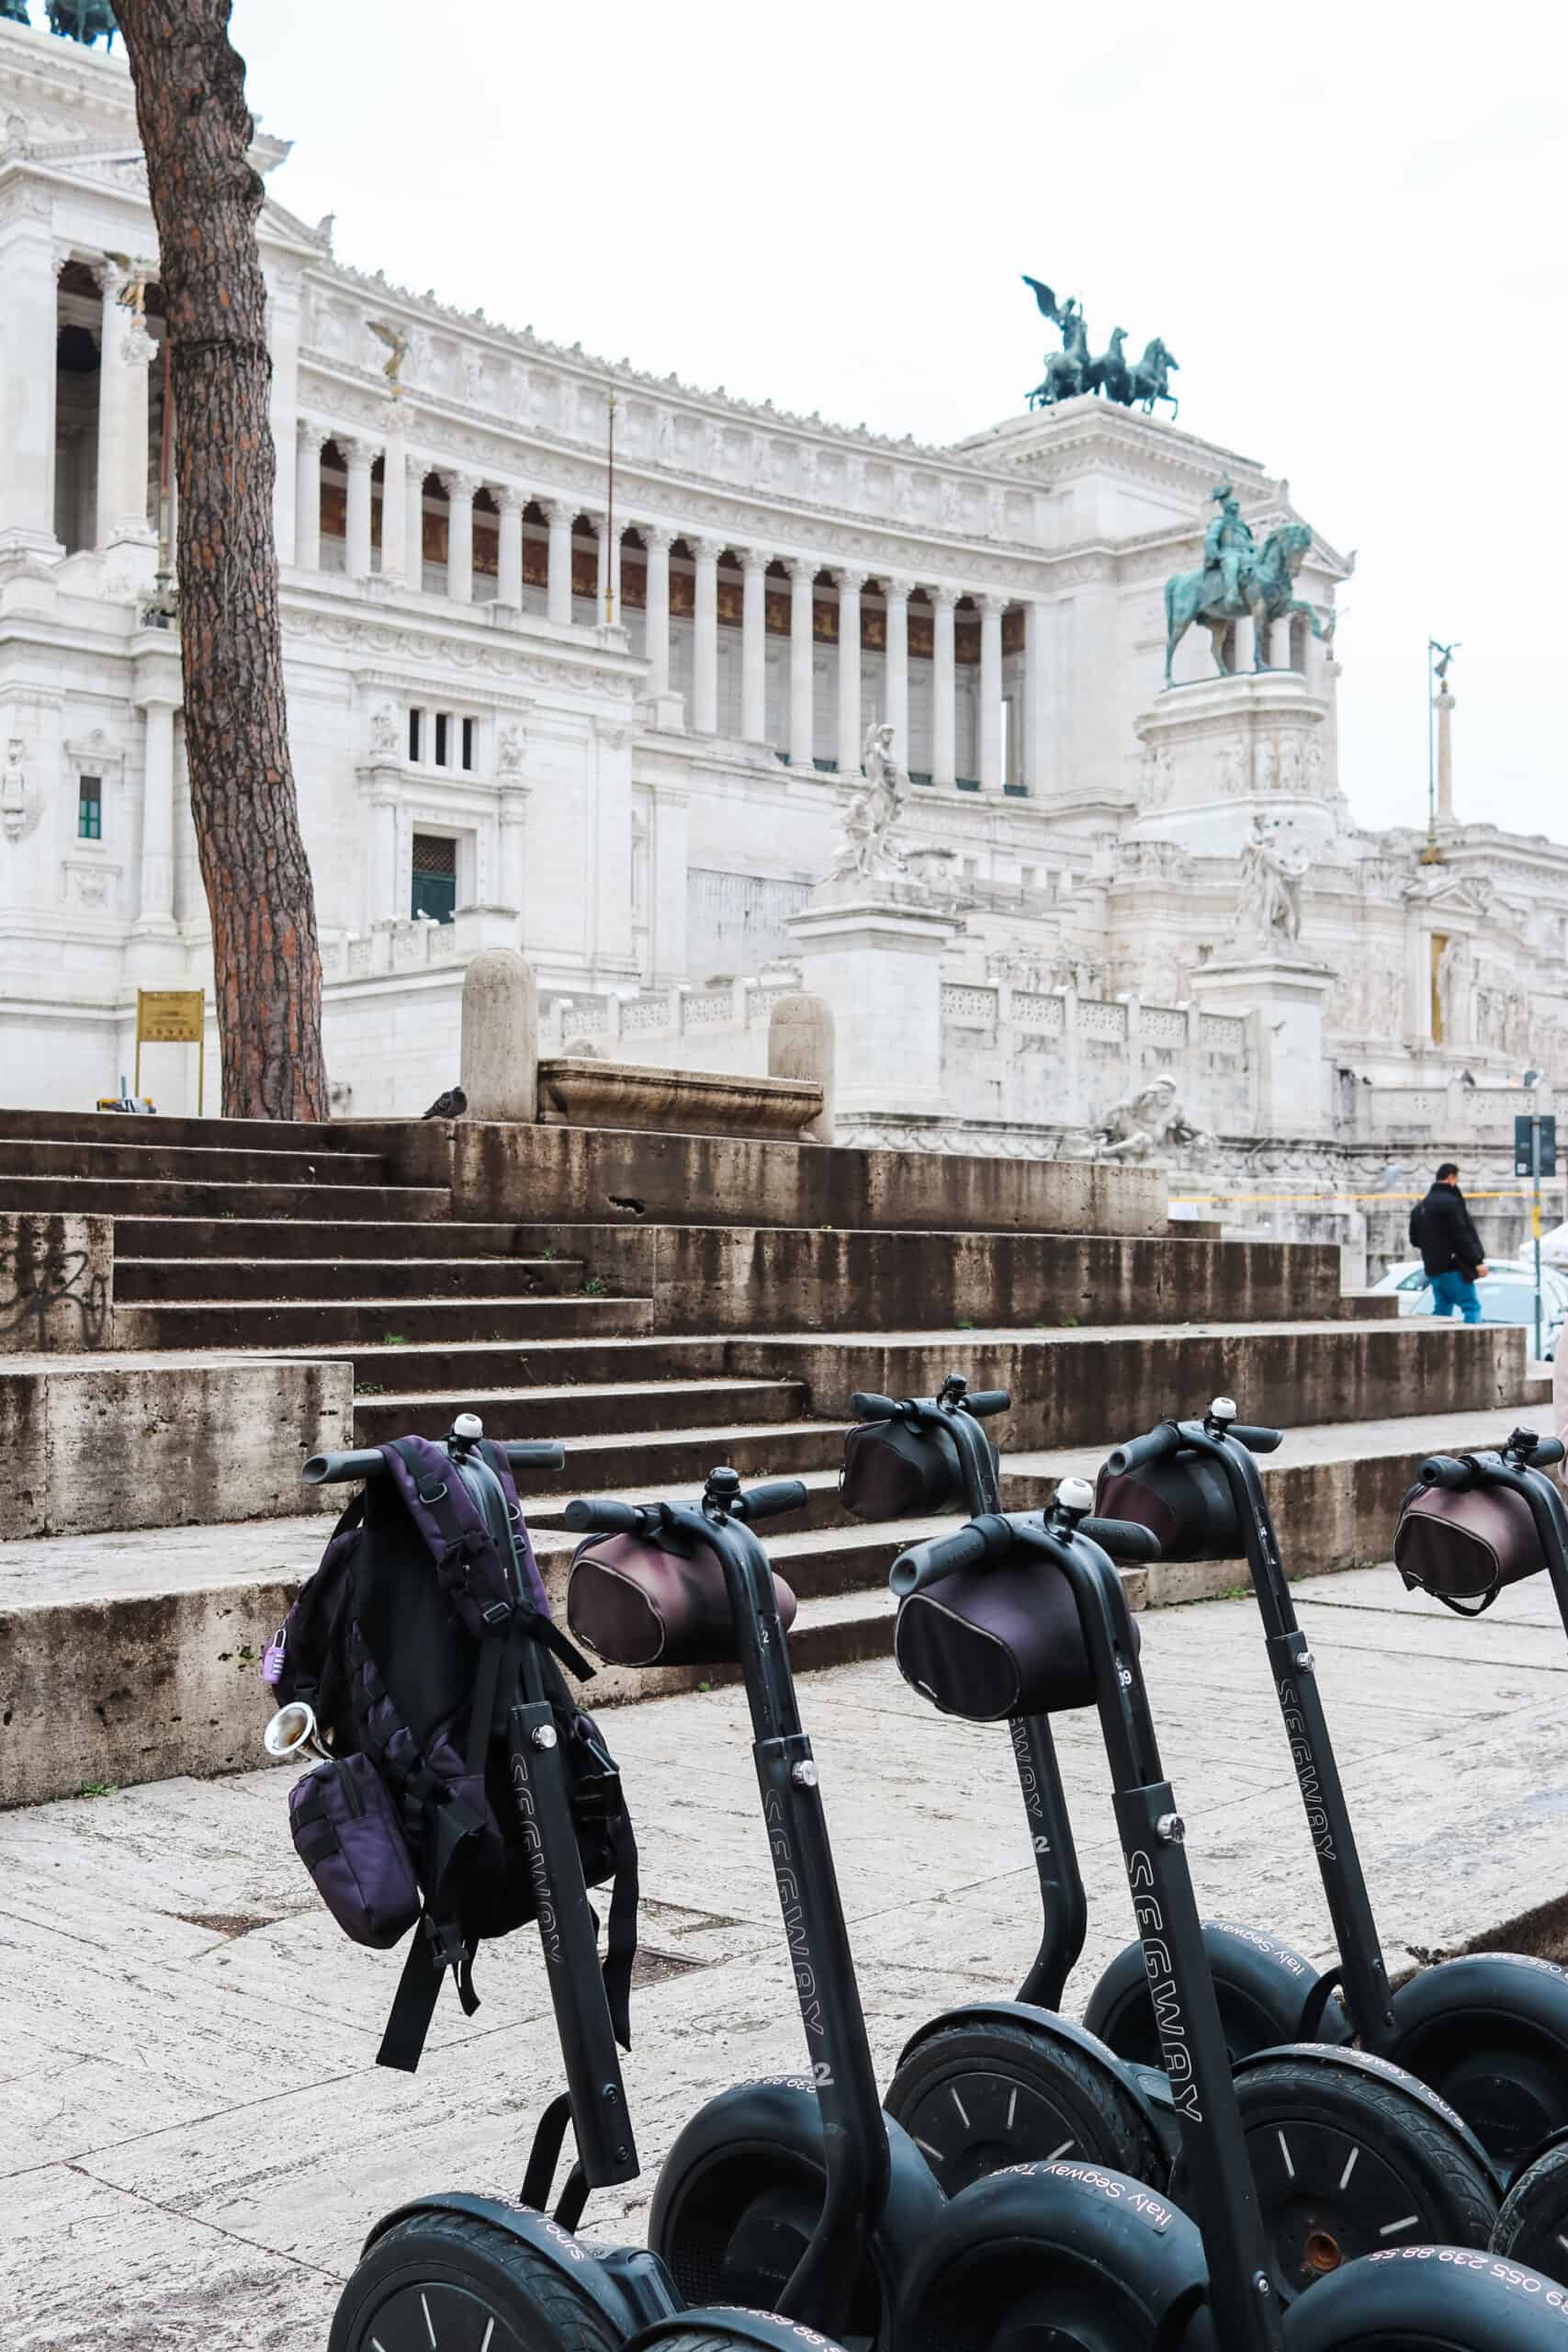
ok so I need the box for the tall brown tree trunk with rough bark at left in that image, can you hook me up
[115,0,327,1120]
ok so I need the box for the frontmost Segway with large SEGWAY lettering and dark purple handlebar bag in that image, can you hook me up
[891,1479,1568,2352]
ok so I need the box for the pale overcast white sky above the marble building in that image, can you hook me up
[232,0,1568,837]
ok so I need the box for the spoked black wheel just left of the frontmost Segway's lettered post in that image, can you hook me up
[882,2018,1168,2197]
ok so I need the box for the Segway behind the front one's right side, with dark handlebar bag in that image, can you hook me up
[1089,1397,1568,2180]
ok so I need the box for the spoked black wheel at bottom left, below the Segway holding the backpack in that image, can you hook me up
[327,2213,621,2352]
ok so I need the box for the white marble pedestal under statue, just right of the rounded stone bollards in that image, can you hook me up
[790,879,962,1117]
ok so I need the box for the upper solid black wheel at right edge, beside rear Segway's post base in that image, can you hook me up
[1389,1952,1568,2180]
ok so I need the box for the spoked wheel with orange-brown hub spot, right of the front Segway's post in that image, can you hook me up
[1170,2051,1504,2304]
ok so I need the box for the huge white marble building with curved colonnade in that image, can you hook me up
[0,21,1568,1131]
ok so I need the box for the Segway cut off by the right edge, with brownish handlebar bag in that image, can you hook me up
[1394,1430,1568,2279]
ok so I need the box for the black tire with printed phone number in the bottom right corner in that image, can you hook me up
[1286,2246,1568,2352]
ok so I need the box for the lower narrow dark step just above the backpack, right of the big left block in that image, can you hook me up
[355,1381,807,1461]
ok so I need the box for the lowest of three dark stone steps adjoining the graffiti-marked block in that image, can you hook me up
[115,1298,653,1354]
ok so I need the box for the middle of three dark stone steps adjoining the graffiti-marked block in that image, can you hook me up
[115,1250,588,1306]
